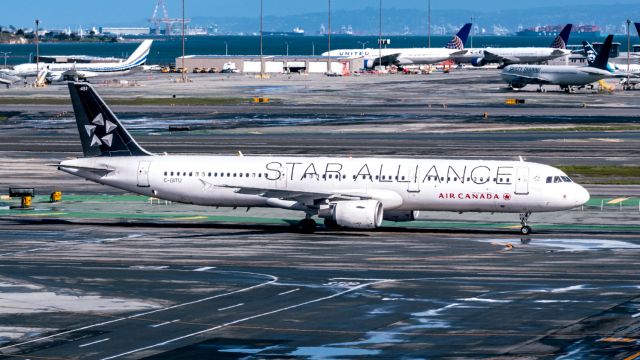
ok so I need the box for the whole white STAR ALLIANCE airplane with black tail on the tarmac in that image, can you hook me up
[58,82,589,234]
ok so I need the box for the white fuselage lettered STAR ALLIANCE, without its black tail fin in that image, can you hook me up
[59,156,589,213]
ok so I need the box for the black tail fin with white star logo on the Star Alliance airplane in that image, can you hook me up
[69,82,152,157]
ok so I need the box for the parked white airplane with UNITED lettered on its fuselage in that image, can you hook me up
[322,24,471,69]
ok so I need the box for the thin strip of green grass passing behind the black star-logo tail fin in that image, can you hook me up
[0,97,253,106]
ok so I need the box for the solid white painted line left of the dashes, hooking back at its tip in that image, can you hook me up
[0,271,278,350]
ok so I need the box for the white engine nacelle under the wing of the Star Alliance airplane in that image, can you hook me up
[318,200,384,229]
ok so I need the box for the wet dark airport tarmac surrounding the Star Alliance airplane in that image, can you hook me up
[0,70,640,359]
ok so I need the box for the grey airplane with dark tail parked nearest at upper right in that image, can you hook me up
[501,35,617,92]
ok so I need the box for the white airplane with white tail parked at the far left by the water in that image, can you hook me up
[4,40,153,82]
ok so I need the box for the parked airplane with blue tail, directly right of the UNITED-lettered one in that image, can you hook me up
[454,24,573,68]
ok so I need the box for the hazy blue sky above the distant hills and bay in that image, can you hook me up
[0,0,629,27]
